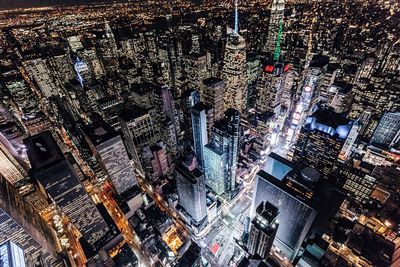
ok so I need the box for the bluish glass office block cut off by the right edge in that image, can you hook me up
[370,112,400,148]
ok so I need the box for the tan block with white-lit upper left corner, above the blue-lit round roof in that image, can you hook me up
[328,81,353,113]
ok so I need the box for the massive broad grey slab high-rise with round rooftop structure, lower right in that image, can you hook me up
[250,153,345,261]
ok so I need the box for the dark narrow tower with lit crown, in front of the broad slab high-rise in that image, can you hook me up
[247,201,279,259]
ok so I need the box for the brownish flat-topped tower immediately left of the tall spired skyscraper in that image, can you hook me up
[203,77,225,121]
